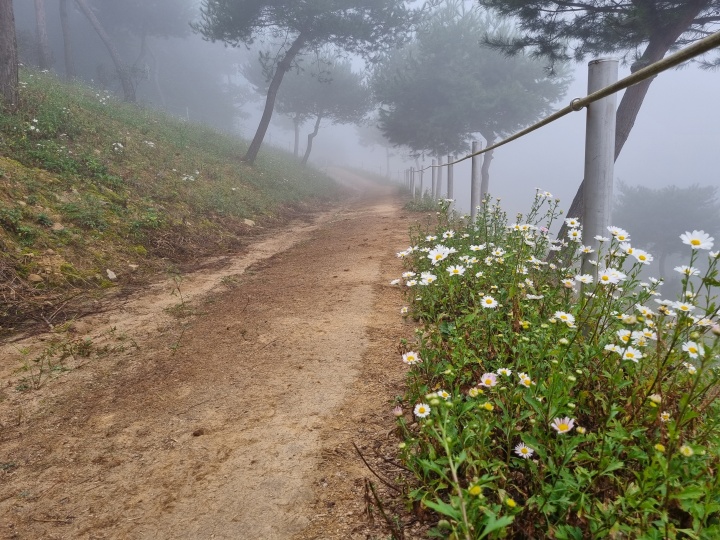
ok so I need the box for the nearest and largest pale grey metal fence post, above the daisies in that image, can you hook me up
[584,58,618,274]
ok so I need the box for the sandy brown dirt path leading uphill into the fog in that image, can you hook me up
[0,171,422,539]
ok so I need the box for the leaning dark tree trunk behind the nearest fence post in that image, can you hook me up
[558,0,708,228]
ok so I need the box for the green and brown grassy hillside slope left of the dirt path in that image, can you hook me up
[0,71,341,336]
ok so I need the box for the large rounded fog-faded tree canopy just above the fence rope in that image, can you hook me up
[373,2,568,192]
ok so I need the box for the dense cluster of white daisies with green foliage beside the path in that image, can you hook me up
[397,191,720,538]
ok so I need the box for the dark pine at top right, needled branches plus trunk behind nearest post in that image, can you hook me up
[478,0,720,223]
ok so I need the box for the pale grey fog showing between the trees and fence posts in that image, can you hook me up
[15,0,720,216]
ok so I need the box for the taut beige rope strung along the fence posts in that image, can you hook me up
[415,31,720,172]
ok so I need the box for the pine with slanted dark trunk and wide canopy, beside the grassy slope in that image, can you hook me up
[193,0,417,163]
